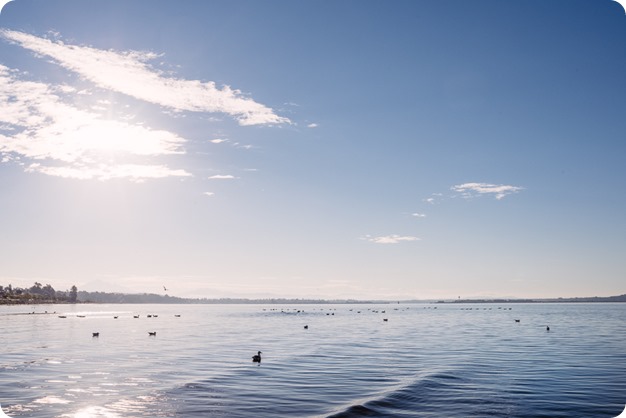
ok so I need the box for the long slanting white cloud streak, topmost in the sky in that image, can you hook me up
[0,30,291,125]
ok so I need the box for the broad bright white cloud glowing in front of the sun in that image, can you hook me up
[0,65,191,181]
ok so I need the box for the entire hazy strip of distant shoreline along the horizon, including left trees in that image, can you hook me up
[0,282,626,305]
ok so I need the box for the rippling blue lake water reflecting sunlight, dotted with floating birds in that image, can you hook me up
[0,303,626,418]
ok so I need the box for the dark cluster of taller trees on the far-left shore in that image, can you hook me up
[0,282,78,305]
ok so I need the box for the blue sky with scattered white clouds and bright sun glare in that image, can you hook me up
[0,0,626,300]
